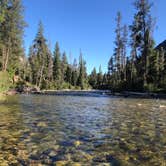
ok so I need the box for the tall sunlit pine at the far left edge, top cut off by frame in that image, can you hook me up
[0,0,25,73]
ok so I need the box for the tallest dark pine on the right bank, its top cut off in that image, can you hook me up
[130,0,152,86]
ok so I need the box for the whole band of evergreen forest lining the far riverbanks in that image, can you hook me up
[0,0,166,91]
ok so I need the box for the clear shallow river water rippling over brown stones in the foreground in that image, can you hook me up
[0,95,166,166]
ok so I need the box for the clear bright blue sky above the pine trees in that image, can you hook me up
[23,0,166,73]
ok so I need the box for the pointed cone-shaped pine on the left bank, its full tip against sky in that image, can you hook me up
[29,22,52,89]
